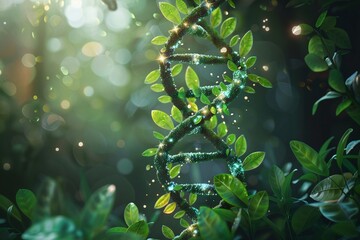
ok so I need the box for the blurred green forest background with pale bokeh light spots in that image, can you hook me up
[0,0,360,236]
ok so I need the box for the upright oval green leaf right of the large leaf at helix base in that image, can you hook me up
[249,191,269,220]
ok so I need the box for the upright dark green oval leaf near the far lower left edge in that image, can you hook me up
[16,189,37,220]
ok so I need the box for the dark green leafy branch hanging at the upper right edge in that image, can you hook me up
[289,6,360,124]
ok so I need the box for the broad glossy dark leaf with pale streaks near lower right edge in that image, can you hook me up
[310,174,345,202]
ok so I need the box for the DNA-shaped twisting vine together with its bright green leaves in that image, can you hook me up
[143,0,271,222]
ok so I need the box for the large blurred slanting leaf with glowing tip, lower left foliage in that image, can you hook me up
[80,185,116,239]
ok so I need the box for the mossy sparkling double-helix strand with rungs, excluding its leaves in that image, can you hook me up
[149,0,252,220]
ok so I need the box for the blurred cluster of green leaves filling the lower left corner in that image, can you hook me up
[0,179,149,240]
